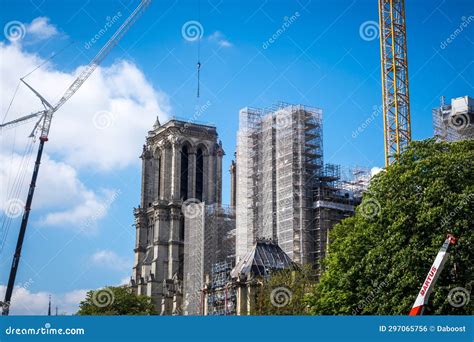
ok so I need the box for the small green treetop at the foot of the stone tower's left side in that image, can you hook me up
[77,286,156,316]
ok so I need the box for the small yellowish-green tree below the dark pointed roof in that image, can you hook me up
[252,267,315,315]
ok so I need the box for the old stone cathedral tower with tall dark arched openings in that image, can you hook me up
[131,119,224,315]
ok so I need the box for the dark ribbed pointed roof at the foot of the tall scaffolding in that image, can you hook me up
[230,240,298,279]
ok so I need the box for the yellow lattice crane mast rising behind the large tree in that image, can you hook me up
[379,0,411,167]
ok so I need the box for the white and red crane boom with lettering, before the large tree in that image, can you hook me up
[409,234,457,316]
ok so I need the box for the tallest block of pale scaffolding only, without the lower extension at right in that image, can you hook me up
[236,103,323,263]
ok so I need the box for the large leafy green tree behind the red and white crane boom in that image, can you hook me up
[307,139,474,315]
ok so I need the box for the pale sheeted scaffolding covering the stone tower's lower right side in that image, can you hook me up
[183,203,235,315]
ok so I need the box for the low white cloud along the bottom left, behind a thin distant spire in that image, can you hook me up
[0,285,87,315]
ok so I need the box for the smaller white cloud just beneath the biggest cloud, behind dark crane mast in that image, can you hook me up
[0,153,118,233]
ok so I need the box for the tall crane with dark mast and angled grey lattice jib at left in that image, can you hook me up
[0,0,151,316]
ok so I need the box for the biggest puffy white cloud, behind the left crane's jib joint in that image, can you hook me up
[0,43,169,171]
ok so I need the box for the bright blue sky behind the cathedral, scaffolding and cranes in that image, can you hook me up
[0,0,474,313]
